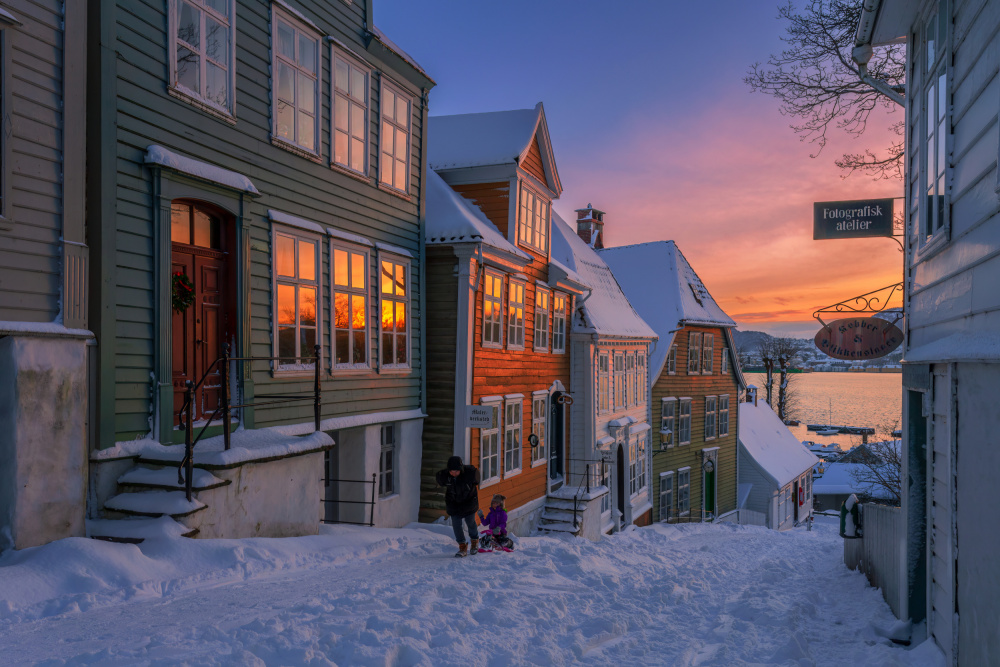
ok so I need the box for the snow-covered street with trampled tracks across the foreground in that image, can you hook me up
[0,524,943,665]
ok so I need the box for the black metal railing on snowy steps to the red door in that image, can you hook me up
[177,343,323,501]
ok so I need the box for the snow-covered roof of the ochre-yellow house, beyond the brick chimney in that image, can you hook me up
[598,241,736,378]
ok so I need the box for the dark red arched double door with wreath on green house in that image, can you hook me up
[170,199,236,424]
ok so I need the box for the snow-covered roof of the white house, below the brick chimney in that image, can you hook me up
[552,211,656,338]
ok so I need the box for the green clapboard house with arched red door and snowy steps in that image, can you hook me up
[87,0,433,536]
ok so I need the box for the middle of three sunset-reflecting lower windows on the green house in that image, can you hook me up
[330,243,369,368]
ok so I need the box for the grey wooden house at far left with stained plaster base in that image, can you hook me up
[0,0,88,551]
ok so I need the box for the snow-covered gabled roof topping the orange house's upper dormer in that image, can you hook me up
[427,102,562,196]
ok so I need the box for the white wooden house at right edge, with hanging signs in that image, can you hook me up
[856,0,1000,665]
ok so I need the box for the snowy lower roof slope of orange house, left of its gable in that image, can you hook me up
[425,169,530,259]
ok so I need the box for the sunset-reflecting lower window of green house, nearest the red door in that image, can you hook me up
[273,229,319,370]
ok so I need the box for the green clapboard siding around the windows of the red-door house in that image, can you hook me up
[97,0,424,447]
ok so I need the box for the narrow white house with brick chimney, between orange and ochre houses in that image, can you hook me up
[540,205,657,539]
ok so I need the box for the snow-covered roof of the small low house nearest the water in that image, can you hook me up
[739,401,819,489]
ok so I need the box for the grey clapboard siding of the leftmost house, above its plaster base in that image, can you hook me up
[0,0,64,322]
